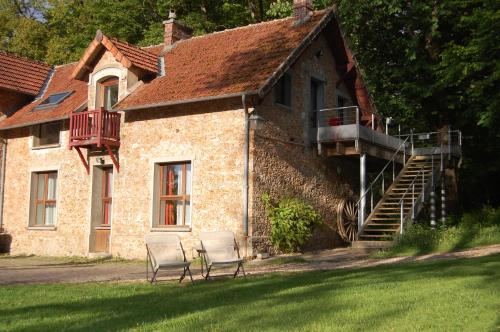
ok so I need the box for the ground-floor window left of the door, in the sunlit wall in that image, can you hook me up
[30,171,57,226]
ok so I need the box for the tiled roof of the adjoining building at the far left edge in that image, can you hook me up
[0,51,51,96]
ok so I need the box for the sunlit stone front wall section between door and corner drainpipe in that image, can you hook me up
[111,99,244,257]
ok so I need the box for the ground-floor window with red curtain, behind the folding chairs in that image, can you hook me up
[154,162,191,227]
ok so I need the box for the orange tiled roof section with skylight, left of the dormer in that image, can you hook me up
[0,63,88,129]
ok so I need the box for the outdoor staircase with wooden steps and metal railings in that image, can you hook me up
[353,131,461,248]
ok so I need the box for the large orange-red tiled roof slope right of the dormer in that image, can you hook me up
[118,11,331,109]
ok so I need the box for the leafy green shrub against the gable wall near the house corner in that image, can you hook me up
[262,194,322,252]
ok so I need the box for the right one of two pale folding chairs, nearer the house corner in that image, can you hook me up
[200,231,246,279]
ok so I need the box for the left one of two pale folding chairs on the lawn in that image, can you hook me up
[145,233,193,283]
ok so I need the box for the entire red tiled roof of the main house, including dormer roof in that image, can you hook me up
[0,10,376,129]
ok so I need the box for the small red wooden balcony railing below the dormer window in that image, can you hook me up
[69,108,121,149]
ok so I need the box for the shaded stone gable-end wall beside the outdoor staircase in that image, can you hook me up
[251,36,355,252]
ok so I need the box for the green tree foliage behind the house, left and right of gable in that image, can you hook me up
[0,0,500,205]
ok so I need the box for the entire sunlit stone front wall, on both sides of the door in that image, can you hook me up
[3,99,244,258]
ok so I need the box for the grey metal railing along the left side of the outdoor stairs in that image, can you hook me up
[356,136,410,234]
